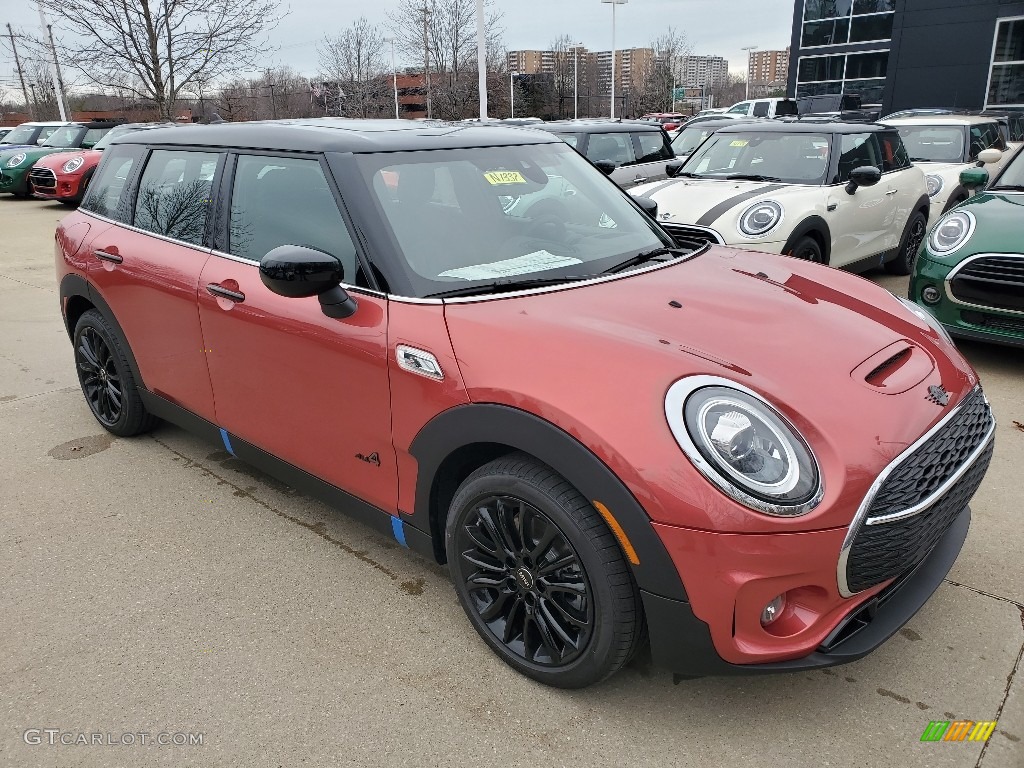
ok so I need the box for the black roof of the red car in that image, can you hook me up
[111,118,558,153]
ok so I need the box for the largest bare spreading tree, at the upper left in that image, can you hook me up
[39,0,281,119]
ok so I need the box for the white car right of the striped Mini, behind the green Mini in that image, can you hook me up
[884,115,1013,222]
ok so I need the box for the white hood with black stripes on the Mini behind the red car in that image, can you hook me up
[629,178,805,230]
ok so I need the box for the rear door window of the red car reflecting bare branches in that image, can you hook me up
[135,150,219,246]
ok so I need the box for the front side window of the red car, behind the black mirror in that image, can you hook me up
[229,155,360,284]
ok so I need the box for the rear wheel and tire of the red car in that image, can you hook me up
[74,309,158,437]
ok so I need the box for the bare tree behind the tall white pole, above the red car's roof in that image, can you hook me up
[389,0,502,120]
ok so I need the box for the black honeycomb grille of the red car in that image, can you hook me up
[846,389,992,592]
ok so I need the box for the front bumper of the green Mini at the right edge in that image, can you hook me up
[909,252,1024,346]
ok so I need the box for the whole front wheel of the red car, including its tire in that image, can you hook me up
[444,454,643,688]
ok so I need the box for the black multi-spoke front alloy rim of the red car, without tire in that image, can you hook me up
[457,496,594,667]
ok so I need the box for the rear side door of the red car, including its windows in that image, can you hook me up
[82,145,224,421]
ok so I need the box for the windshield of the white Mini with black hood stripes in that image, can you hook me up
[681,131,829,184]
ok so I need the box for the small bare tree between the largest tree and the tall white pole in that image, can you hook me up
[317,17,393,118]
